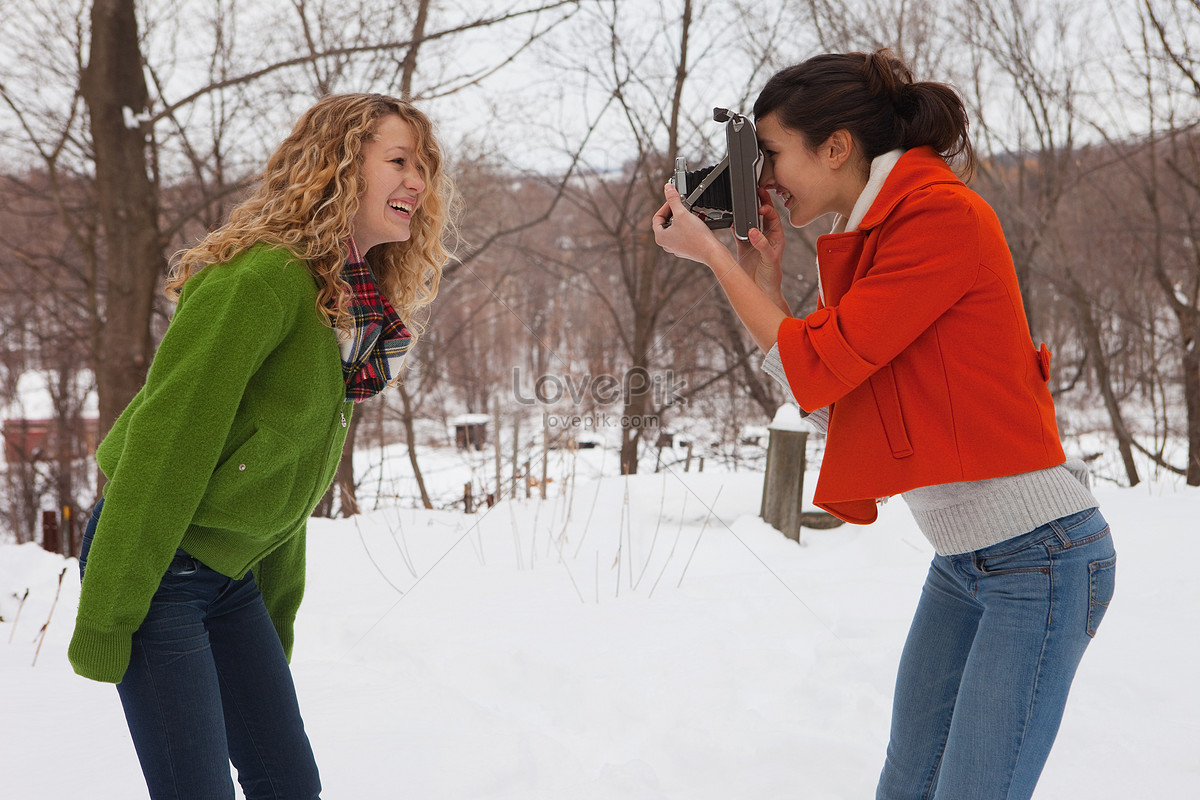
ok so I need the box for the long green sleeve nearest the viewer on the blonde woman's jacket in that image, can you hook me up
[67,264,287,682]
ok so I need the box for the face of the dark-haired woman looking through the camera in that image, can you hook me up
[755,114,863,228]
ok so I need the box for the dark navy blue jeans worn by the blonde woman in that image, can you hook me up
[79,500,320,800]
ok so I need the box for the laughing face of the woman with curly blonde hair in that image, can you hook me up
[353,114,425,253]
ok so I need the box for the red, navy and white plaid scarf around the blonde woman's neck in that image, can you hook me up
[338,239,413,403]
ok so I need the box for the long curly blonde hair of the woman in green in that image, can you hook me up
[166,95,455,341]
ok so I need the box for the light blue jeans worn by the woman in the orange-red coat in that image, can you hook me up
[875,509,1116,800]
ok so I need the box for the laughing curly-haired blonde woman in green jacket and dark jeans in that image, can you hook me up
[68,95,451,800]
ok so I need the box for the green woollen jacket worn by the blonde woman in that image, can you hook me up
[67,245,353,682]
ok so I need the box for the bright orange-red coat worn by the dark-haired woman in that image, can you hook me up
[779,148,1066,523]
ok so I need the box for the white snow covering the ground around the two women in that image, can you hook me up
[0,450,1200,800]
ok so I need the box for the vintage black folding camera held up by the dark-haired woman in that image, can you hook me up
[671,108,762,241]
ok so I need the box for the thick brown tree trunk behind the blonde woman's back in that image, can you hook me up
[80,0,164,435]
